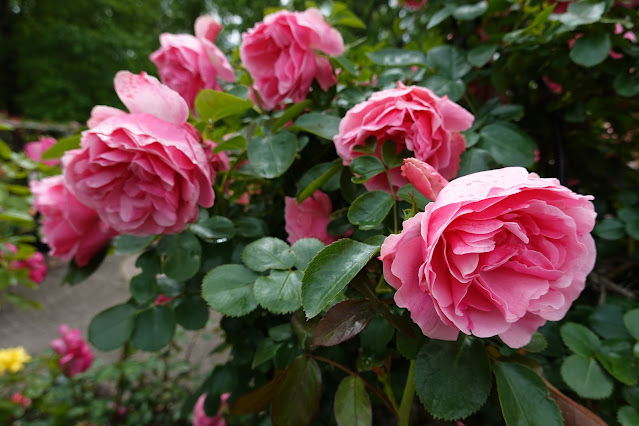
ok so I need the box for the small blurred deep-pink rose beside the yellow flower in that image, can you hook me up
[51,324,93,377]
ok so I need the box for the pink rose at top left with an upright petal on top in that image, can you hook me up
[149,16,235,109]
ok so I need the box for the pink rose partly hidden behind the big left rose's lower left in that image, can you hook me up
[29,175,117,266]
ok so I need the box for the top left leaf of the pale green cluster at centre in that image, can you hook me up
[242,237,296,272]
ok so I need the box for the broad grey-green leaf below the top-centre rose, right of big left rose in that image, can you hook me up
[247,131,297,179]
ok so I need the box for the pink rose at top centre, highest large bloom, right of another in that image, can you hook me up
[240,9,344,110]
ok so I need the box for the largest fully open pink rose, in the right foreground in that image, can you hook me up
[380,167,596,348]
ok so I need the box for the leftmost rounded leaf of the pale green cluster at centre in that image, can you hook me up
[202,265,258,317]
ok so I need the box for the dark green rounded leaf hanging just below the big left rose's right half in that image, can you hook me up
[158,231,202,281]
